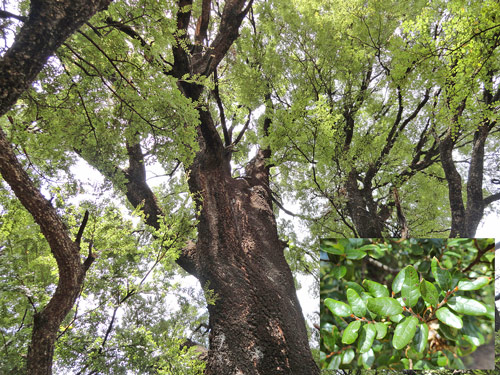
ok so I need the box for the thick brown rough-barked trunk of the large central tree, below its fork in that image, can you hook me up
[189,146,319,375]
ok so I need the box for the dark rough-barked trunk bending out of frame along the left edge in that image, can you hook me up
[0,0,110,375]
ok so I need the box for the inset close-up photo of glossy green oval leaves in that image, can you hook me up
[320,238,495,370]
